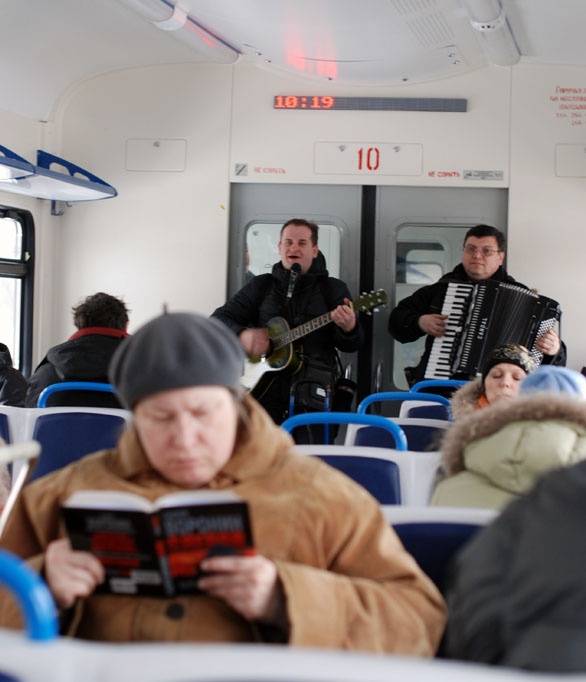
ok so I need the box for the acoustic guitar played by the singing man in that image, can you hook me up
[240,289,387,399]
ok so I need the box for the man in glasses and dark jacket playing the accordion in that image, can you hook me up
[388,225,566,386]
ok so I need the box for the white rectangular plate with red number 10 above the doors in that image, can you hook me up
[314,142,423,175]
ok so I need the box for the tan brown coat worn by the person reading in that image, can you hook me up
[0,398,445,656]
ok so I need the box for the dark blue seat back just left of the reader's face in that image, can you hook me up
[29,412,126,481]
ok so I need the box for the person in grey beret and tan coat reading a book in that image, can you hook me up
[0,313,445,656]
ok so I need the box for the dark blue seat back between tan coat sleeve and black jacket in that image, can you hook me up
[393,521,482,593]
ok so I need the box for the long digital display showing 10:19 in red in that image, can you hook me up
[273,95,468,112]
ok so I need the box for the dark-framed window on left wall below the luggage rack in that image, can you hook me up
[0,206,34,375]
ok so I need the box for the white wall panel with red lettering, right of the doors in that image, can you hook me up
[508,64,586,369]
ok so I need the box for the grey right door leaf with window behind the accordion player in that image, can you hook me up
[371,187,508,391]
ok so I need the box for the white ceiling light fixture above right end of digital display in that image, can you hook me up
[464,0,521,66]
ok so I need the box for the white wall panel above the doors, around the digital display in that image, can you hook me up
[230,63,510,187]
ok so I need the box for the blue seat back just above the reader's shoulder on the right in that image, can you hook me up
[316,455,401,504]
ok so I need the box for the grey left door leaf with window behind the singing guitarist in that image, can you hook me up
[228,184,362,379]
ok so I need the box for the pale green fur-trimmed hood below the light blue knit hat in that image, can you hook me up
[441,393,586,493]
